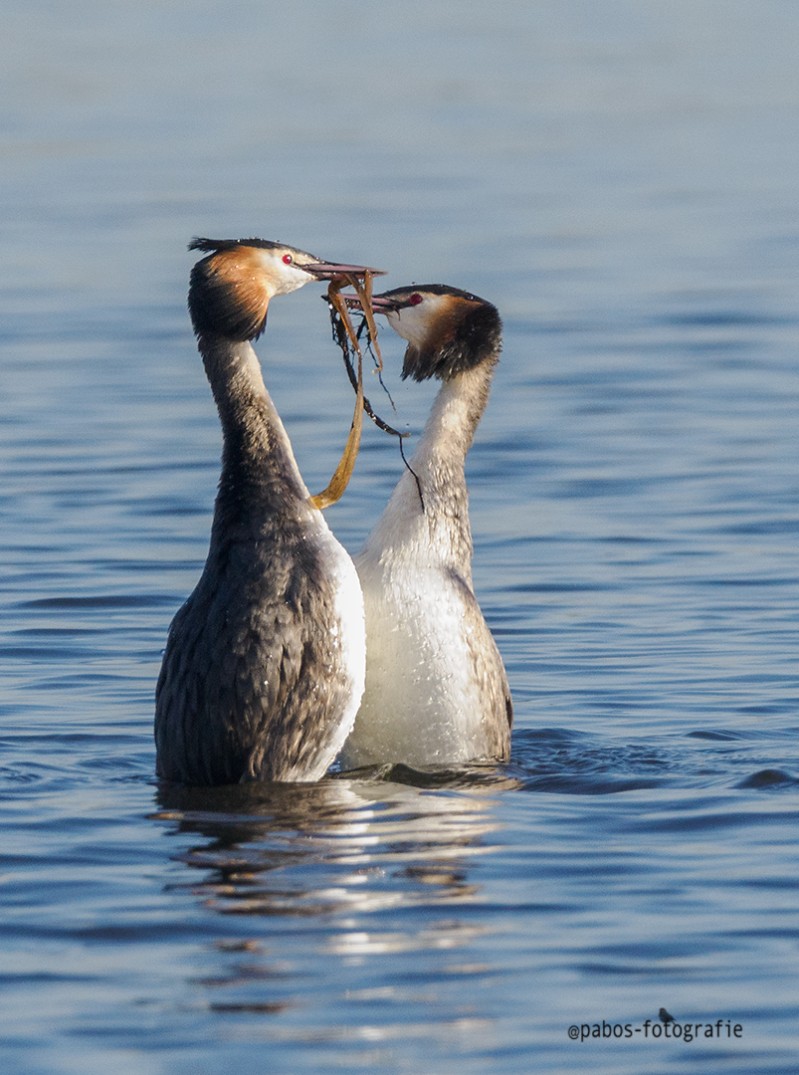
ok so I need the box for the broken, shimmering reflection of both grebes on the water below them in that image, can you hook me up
[154,770,516,1049]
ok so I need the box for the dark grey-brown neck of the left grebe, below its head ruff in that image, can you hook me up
[199,336,308,531]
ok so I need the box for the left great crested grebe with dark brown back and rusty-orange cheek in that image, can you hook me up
[155,239,380,785]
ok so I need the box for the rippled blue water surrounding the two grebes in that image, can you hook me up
[0,0,799,1075]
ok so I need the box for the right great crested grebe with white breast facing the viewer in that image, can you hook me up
[341,284,513,769]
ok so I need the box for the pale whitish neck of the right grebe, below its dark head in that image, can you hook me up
[365,361,495,584]
